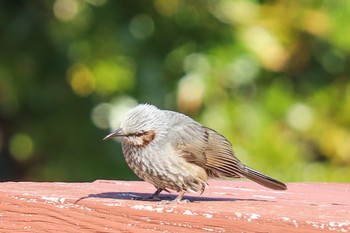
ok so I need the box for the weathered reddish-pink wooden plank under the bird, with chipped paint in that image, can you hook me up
[0,180,350,232]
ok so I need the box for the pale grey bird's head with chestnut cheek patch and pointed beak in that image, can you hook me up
[104,104,168,147]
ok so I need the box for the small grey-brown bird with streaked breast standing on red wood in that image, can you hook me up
[104,104,287,203]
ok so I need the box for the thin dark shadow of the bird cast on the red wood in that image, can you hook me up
[74,192,268,204]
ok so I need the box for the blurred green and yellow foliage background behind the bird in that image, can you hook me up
[0,0,350,182]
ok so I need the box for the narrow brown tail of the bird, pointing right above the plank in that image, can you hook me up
[240,166,287,190]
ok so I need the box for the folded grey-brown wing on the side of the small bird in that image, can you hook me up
[165,111,243,177]
